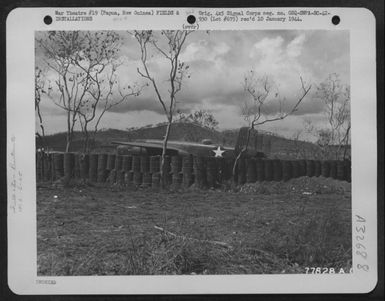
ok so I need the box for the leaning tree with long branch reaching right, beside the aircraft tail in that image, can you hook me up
[233,70,311,177]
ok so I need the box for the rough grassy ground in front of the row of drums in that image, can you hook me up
[37,177,352,276]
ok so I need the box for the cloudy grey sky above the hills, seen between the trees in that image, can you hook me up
[36,30,350,137]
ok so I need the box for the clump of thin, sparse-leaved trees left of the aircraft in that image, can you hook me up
[35,31,140,152]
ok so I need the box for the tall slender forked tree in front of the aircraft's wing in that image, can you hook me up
[132,30,191,186]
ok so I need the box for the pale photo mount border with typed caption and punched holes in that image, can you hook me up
[6,7,377,294]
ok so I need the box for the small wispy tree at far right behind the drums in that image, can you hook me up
[316,73,351,159]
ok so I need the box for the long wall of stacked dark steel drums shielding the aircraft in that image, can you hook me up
[36,152,351,189]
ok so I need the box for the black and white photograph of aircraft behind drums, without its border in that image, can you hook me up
[35,30,352,276]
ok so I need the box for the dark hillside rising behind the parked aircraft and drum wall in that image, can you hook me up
[36,123,340,159]
